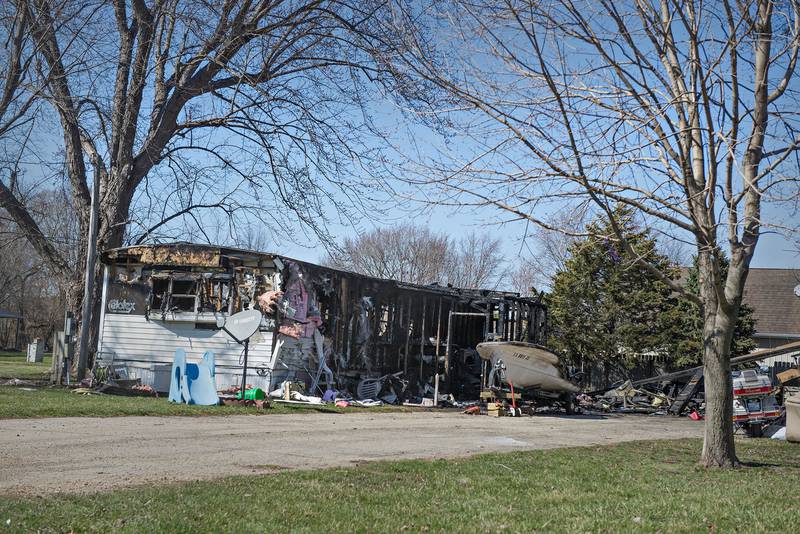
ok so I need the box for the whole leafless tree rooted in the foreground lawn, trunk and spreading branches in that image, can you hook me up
[400,0,800,466]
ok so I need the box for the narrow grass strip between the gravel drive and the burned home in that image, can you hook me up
[0,386,418,420]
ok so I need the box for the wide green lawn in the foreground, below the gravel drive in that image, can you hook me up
[0,439,800,533]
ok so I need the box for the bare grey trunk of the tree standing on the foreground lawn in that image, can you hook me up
[698,253,738,467]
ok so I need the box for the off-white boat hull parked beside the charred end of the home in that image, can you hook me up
[475,341,580,393]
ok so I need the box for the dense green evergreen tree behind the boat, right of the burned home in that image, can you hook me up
[548,209,683,370]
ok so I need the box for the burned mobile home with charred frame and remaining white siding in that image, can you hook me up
[96,243,547,398]
